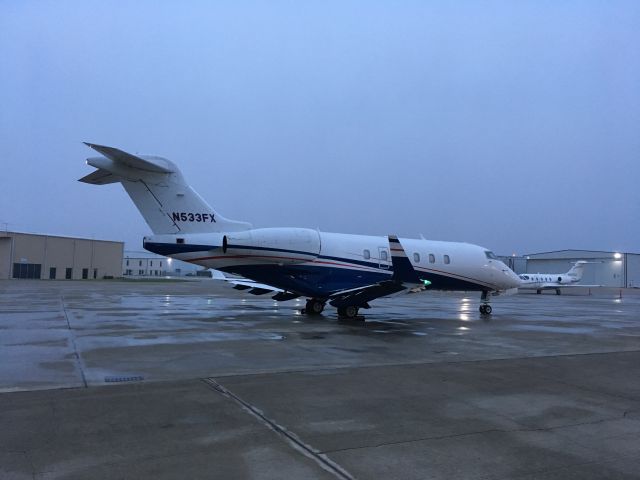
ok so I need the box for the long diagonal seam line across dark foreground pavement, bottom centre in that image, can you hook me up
[202,378,355,480]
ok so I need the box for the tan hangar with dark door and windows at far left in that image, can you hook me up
[0,231,124,280]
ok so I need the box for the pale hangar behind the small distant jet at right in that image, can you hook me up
[503,250,640,288]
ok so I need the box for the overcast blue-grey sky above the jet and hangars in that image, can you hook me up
[0,0,640,254]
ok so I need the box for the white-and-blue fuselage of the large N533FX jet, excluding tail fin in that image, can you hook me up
[144,228,520,297]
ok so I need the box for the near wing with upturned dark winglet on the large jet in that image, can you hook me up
[329,235,427,308]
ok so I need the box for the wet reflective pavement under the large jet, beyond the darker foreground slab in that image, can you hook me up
[0,281,640,390]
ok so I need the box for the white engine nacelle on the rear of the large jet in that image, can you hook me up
[222,228,320,264]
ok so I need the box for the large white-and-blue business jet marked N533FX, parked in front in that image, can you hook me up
[80,143,520,319]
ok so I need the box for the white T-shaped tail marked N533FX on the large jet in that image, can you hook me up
[79,142,251,234]
